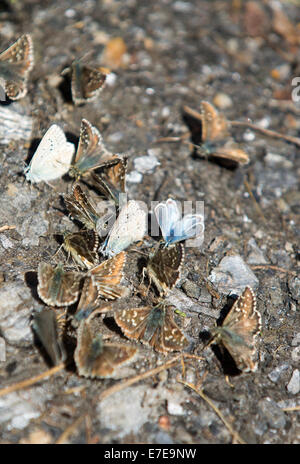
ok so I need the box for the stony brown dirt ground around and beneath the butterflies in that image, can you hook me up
[0,0,300,444]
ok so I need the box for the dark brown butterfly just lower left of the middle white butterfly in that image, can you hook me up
[63,230,99,269]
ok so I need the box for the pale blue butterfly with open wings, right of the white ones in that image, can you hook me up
[154,198,204,246]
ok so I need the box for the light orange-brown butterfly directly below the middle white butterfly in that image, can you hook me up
[89,251,129,300]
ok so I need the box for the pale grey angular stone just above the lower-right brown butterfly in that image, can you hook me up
[209,255,259,295]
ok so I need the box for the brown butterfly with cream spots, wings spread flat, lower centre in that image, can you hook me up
[114,303,189,354]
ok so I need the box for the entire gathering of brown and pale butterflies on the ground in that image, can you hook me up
[0,34,261,378]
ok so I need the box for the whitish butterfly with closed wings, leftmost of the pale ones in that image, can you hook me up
[24,124,75,182]
